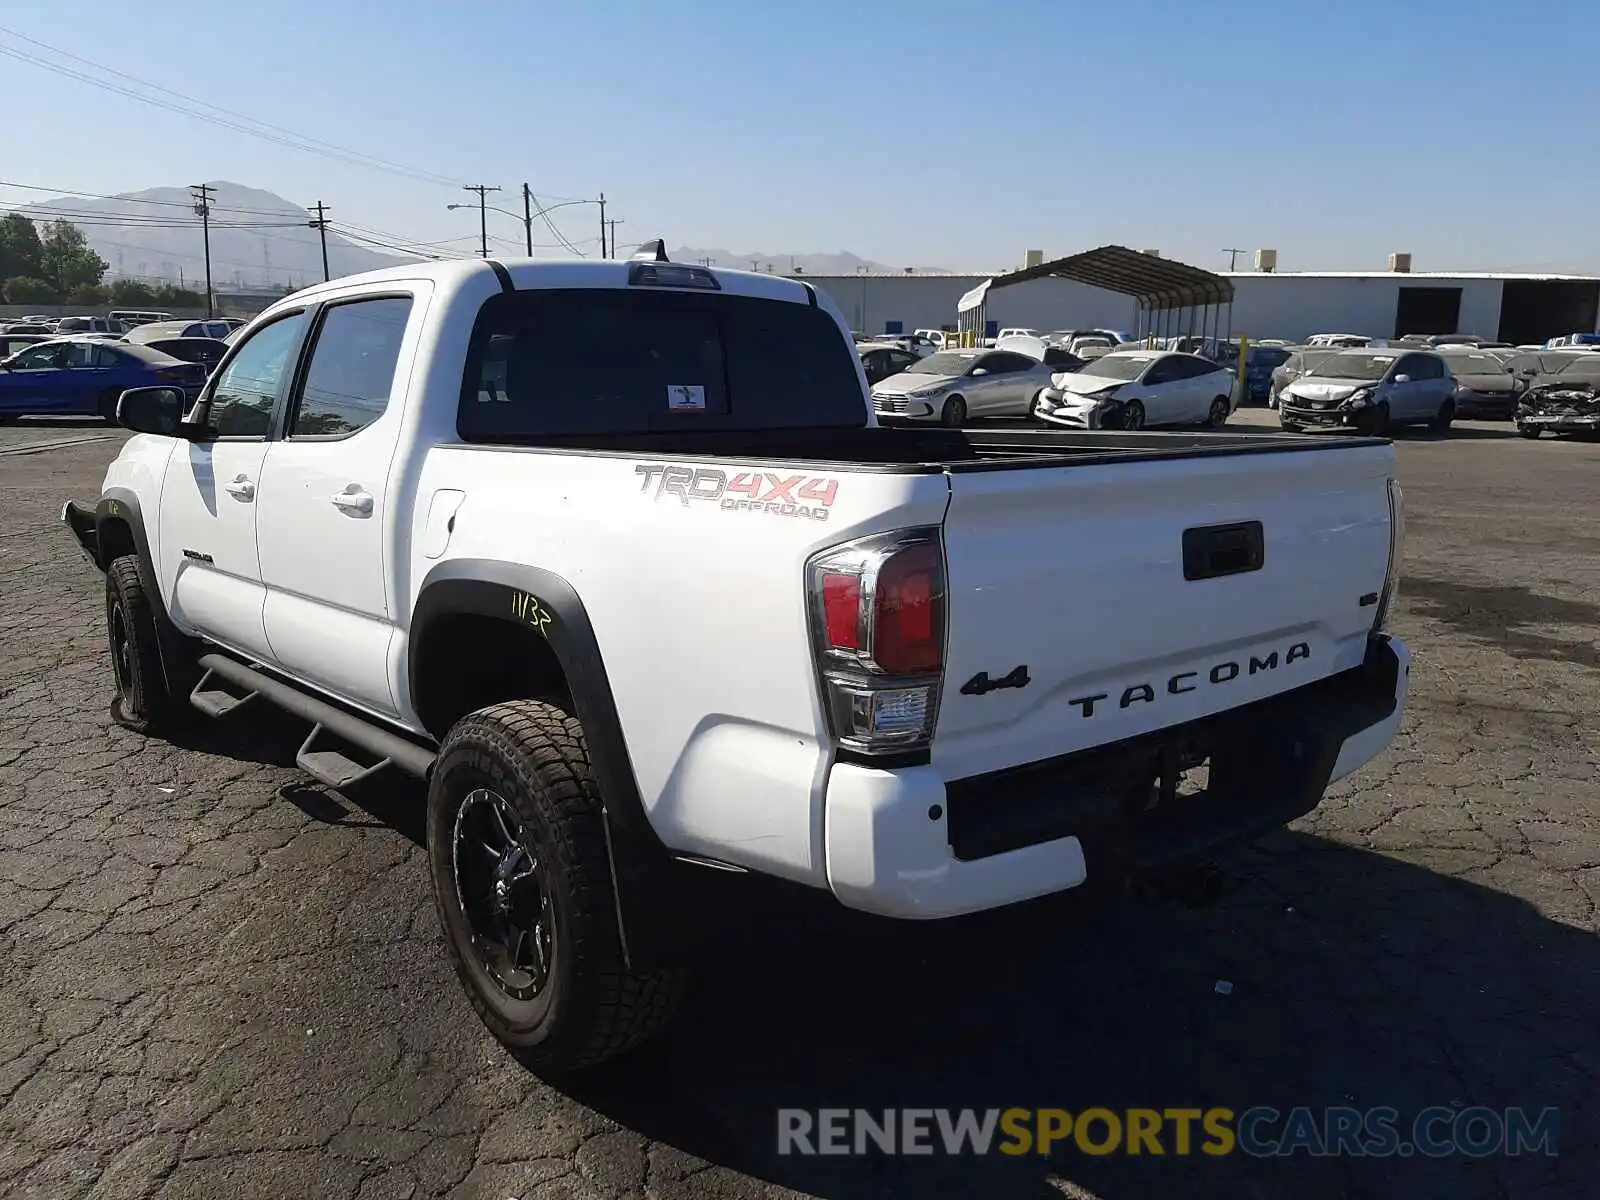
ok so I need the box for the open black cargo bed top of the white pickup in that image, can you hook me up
[489,426,1384,474]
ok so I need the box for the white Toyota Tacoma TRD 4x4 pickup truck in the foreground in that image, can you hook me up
[62,248,1410,1070]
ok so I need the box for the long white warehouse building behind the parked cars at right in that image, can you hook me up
[805,246,1600,346]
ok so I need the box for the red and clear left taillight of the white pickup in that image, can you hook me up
[806,526,946,755]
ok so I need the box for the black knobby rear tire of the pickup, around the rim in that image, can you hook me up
[427,699,688,1074]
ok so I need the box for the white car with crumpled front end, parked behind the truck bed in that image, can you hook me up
[1034,350,1238,429]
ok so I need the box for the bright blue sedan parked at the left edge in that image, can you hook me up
[0,338,208,421]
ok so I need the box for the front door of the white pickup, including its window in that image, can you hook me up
[157,310,306,662]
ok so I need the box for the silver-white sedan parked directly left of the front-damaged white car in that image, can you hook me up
[872,349,1051,429]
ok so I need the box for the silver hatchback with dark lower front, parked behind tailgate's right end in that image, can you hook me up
[1278,349,1456,435]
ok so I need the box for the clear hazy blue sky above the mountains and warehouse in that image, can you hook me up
[0,0,1600,270]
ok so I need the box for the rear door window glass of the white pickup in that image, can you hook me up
[290,296,411,437]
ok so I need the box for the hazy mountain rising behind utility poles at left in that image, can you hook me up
[11,182,414,288]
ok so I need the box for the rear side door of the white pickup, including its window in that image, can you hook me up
[249,294,422,715]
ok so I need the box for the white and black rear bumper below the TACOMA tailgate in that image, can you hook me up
[824,637,1411,918]
